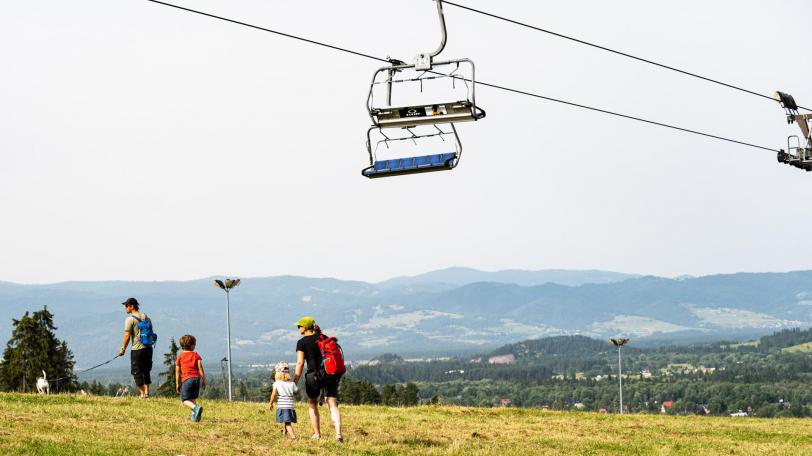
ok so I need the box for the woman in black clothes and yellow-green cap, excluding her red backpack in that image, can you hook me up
[293,317,344,442]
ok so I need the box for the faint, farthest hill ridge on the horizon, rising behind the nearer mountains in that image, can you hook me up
[378,267,640,288]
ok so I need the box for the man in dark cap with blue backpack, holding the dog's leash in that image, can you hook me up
[118,298,154,399]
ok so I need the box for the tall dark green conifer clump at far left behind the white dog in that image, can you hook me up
[0,306,77,392]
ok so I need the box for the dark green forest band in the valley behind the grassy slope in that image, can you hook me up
[0,308,812,417]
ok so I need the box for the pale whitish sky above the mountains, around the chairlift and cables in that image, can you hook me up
[0,0,812,283]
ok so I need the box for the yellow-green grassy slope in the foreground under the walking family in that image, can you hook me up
[0,394,812,455]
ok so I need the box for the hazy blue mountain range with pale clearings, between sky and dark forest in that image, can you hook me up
[0,268,812,369]
